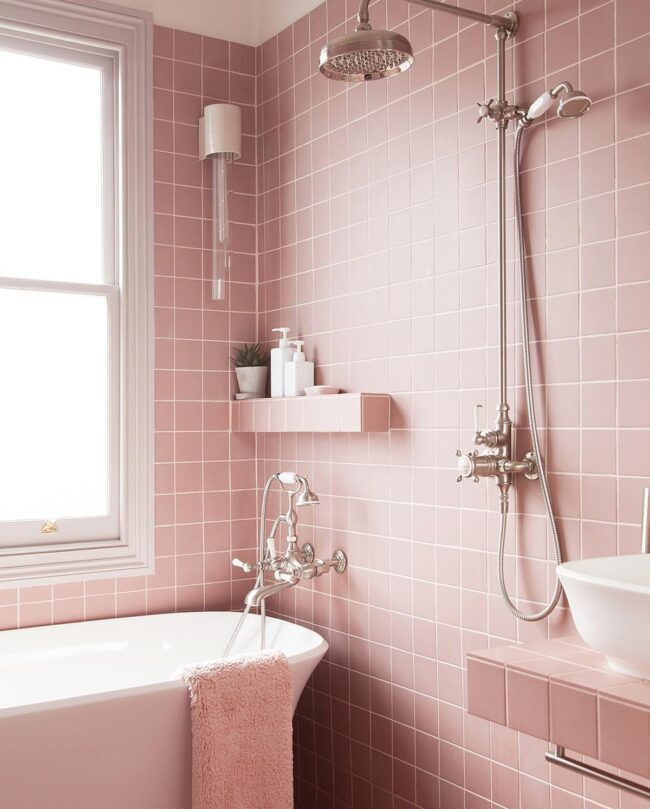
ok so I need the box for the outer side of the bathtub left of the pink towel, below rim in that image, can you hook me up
[0,686,191,809]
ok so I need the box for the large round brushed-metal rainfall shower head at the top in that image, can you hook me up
[320,0,413,81]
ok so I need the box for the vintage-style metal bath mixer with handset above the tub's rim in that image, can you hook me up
[224,472,348,656]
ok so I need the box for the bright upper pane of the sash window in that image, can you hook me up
[0,49,102,283]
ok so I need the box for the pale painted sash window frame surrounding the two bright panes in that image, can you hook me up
[0,0,154,587]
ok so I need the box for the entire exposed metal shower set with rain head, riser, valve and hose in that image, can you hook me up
[320,0,591,621]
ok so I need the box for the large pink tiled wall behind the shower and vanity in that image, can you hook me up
[258,0,650,809]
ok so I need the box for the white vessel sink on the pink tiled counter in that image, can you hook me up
[557,553,650,679]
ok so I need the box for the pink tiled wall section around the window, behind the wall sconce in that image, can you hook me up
[0,23,256,628]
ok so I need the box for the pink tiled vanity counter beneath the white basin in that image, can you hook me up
[467,636,650,777]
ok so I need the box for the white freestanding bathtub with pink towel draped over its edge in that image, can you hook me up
[0,612,327,809]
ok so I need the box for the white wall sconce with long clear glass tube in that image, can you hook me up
[199,104,241,301]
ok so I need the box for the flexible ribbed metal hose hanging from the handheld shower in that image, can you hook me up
[498,124,562,621]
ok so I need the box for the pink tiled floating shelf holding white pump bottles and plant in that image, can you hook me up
[230,393,390,433]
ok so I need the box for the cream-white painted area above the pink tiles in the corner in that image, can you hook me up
[113,0,323,45]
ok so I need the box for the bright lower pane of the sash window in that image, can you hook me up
[0,289,109,520]
